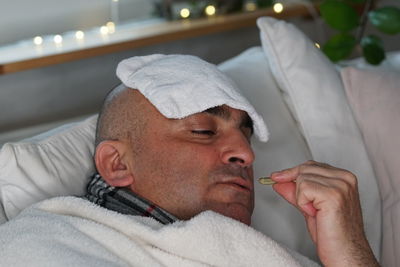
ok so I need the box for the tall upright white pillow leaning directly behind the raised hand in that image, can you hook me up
[257,17,382,259]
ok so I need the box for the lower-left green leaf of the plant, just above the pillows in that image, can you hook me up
[322,33,356,62]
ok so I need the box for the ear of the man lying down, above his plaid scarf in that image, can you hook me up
[95,141,134,187]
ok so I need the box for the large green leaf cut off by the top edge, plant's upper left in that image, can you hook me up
[320,0,360,32]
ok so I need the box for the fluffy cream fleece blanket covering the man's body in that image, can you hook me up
[0,197,317,267]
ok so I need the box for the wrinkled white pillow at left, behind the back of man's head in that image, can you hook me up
[0,115,97,220]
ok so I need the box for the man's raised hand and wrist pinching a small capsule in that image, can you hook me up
[271,161,379,267]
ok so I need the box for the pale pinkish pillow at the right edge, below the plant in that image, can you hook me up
[341,67,400,266]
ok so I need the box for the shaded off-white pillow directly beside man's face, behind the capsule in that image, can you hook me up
[219,47,317,260]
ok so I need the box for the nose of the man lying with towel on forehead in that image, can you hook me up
[221,130,255,167]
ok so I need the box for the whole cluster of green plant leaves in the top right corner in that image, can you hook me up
[320,0,400,65]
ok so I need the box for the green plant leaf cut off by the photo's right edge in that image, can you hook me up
[368,6,400,34]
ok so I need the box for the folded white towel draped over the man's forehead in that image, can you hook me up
[117,54,268,142]
